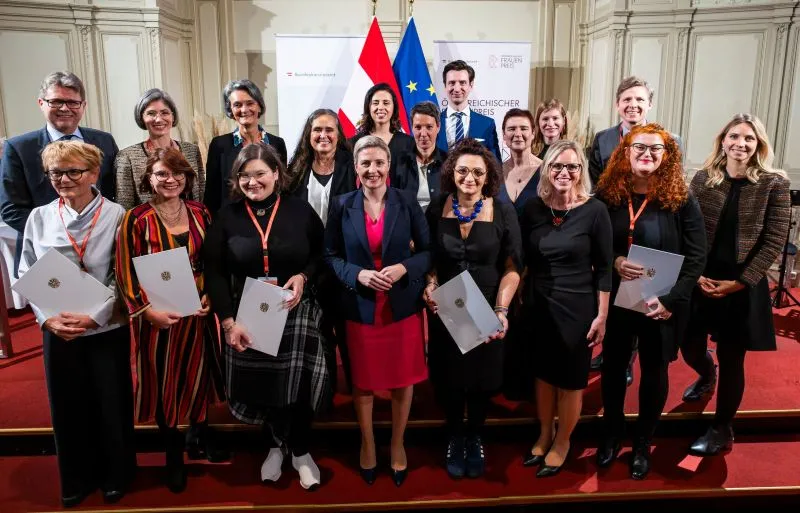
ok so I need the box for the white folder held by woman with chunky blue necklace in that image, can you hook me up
[431,271,503,354]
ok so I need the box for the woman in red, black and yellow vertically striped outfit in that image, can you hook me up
[116,149,228,493]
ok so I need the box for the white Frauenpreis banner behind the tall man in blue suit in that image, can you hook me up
[433,41,531,160]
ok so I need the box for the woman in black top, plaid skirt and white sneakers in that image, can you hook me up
[204,143,330,489]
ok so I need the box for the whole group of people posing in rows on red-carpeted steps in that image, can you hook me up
[0,61,790,506]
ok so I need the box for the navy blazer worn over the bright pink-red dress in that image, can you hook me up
[324,187,431,324]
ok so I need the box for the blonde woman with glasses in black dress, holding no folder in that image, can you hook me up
[520,141,613,477]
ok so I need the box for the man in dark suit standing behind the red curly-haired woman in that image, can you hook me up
[589,76,683,186]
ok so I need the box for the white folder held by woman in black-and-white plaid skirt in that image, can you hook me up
[236,278,292,356]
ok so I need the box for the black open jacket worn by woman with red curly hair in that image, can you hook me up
[598,193,706,361]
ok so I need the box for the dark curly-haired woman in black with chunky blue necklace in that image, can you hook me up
[425,139,522,478]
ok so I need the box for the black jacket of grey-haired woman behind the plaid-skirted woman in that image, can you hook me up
[203,132,286,214]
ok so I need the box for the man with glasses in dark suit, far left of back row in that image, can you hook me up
[0,71,118,274]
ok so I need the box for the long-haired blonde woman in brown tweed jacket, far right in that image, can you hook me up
[681,114,791,455]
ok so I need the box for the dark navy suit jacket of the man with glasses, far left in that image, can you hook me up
[0,127,119,273]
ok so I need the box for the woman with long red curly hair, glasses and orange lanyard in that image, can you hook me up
[597,124,706,479]
